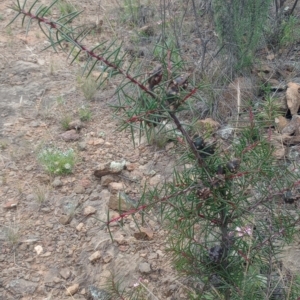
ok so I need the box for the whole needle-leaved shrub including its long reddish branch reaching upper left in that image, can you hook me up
[7,0,299,300]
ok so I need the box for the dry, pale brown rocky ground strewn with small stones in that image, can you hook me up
[0,0,300,300]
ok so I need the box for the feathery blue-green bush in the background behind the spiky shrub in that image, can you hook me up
[213,0,272,70]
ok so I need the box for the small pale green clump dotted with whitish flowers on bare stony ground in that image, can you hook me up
[38,148,75,175]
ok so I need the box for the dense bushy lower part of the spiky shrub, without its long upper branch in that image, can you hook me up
[164,120,299,299]
